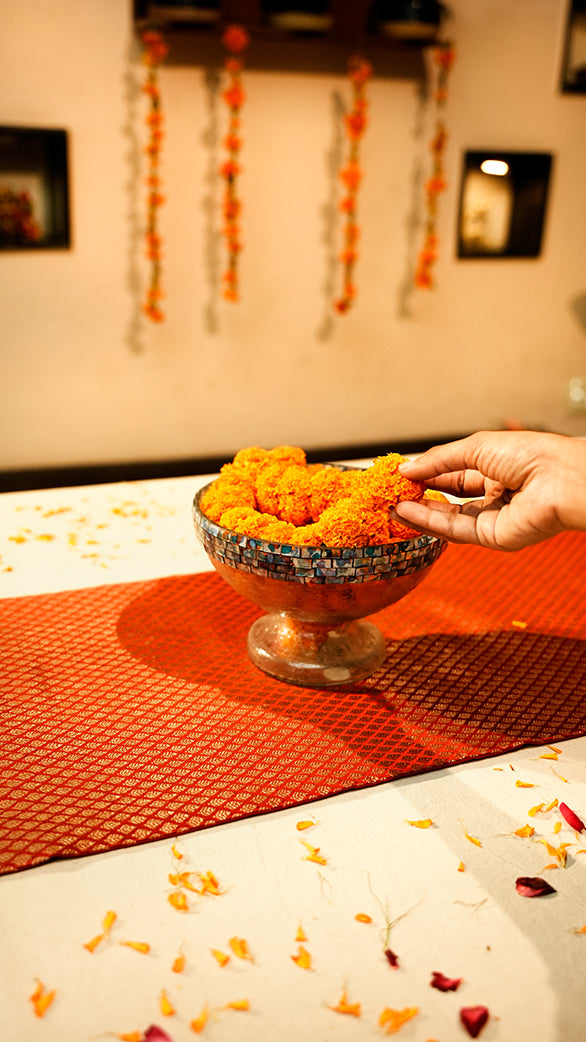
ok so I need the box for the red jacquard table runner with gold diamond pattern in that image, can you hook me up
[0,534,586,872]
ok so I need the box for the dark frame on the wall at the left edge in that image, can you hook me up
[0,126,71,250]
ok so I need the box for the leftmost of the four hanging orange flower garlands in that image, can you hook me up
[142,29,169,322]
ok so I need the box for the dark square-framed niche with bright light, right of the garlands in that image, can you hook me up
[457,149,554,259]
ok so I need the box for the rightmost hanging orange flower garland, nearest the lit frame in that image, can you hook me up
[414,44,456,290]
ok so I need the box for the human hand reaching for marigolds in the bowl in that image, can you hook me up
[394,430,586,550]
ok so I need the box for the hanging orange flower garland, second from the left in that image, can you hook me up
[220,25,250,302]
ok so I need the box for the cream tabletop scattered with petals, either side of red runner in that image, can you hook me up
[0,475,586,1042]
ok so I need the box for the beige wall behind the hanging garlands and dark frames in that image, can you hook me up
[0,0,586,468]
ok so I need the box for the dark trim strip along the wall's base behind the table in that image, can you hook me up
[0,435,464,492]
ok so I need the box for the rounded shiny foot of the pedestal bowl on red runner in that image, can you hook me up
[248,614,386,688]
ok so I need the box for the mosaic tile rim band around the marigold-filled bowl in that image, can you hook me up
[192,479,447,585]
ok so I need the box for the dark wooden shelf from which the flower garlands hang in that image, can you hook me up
[135,0,434,80]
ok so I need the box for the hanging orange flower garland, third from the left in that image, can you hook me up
[334,55,372,315]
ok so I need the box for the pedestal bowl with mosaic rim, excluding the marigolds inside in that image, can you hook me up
[193,486,446,688]
